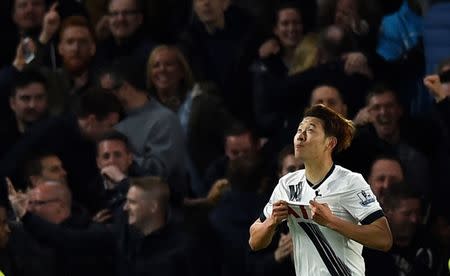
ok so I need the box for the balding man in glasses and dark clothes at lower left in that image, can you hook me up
[19,179,114,275]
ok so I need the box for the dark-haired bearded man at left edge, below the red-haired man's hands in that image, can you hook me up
[0,71,47,156]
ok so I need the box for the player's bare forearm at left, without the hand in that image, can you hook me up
[248,218,277,251]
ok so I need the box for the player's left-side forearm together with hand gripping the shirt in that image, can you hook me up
[248,200,288,251]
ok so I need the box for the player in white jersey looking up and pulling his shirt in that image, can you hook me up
[249,105,392,275]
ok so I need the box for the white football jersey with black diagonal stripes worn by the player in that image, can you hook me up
[261,165,384,276]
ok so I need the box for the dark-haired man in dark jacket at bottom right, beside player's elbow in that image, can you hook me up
[364,183,437,275]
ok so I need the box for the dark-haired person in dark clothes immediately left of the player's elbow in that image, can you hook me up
[210,155,267,276]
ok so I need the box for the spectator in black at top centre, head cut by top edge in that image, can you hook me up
[181,0,257,122]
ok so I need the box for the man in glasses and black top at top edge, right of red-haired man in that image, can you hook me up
[97,0,155,67]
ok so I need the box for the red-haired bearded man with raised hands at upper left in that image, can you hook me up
[0,14,96,115]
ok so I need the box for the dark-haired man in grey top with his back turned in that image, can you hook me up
[100,59,187,203]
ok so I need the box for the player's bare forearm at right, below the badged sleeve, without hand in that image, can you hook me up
[328,217,392,252]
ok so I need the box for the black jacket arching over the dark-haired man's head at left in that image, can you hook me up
[0,115,98,204]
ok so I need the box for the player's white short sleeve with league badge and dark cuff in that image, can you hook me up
[341,174,384,224]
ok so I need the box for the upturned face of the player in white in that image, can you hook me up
[294,117,329,162]
